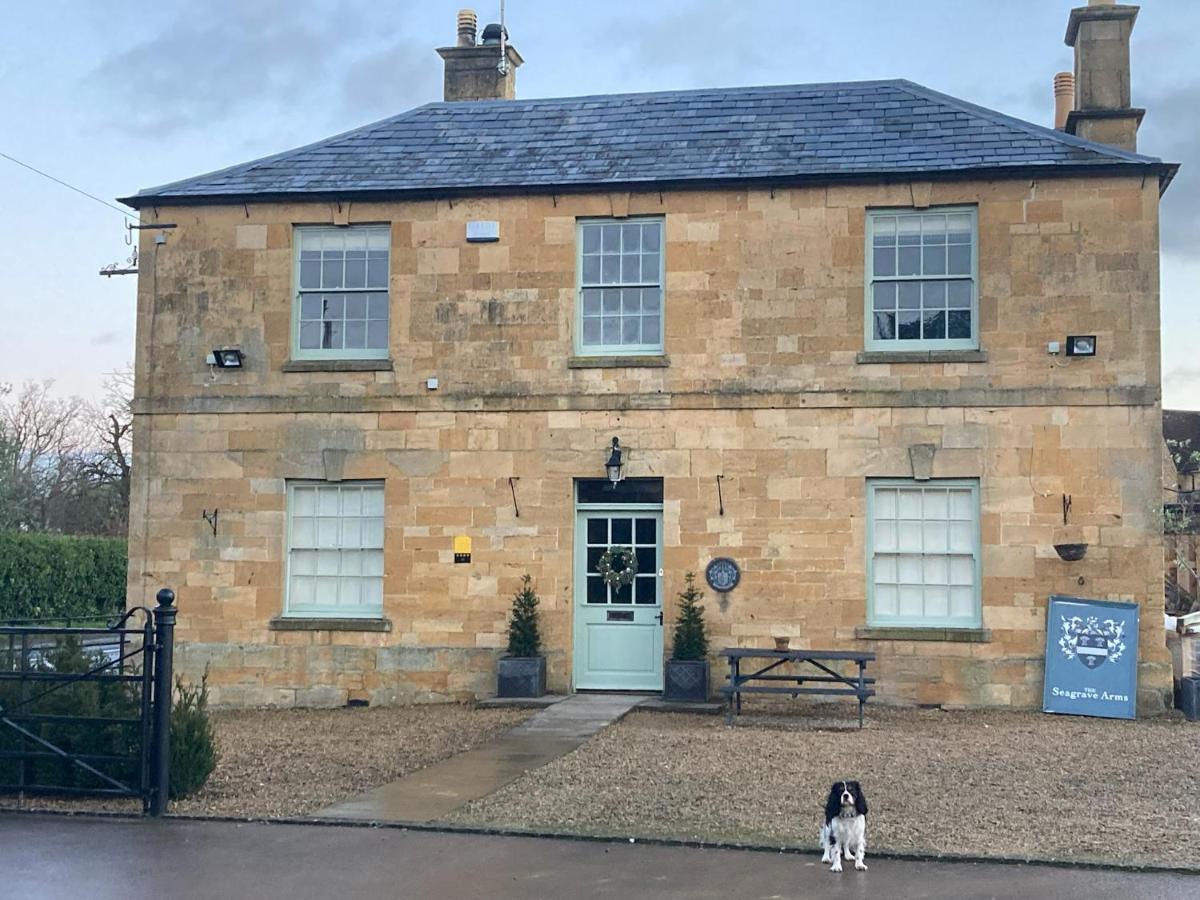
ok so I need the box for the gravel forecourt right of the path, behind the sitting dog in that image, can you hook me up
[452,706,1200,868]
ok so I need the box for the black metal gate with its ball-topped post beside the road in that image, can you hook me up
[0,588,175,816]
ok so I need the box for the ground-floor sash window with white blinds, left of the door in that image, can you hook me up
[284,481,383,618]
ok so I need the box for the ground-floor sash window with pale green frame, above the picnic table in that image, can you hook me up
[866,479,983,629]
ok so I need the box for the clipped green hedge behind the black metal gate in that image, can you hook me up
[0,533,128,619]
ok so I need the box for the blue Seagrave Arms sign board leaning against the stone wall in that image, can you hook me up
[1042,595,1139,719]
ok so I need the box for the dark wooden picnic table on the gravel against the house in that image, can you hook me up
[720,647,875,728]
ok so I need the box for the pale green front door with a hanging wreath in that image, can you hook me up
[575,506,662,691]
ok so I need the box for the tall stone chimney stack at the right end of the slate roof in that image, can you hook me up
[1055,0,1146,150]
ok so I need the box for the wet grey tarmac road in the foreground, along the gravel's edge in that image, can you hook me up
[7,814,1200,900]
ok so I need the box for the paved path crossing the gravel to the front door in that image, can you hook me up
[316,694,644,822]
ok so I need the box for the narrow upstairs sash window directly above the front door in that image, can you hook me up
[576,218,662,355]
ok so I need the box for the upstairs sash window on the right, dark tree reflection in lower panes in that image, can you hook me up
[866,206,979,350]
